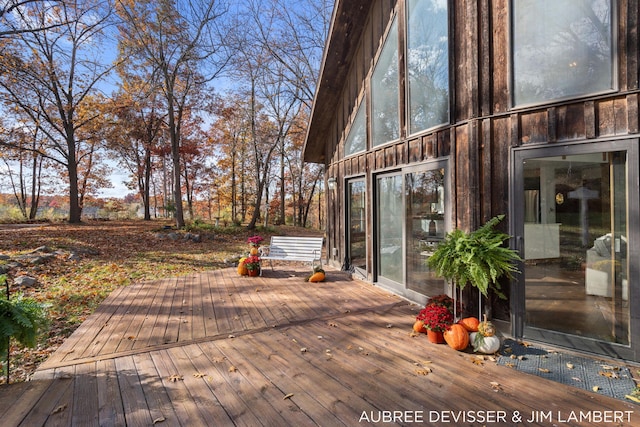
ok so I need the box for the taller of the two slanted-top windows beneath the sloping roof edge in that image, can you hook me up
[371,20,400,146]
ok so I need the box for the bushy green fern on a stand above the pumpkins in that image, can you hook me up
[427,215,521,320]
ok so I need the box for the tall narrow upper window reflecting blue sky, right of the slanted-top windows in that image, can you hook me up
[407,0,449,133]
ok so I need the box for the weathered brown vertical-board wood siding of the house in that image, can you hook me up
[307,0,640,362]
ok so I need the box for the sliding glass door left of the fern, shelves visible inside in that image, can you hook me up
[375,161,448,301]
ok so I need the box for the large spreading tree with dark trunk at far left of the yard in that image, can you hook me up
[0,0,117,223]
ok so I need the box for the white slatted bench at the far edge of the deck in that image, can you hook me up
[258,236,324,275]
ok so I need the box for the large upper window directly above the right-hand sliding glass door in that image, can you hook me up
[511,0,615,105]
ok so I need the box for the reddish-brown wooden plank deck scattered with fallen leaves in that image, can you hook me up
[0,267,640,427]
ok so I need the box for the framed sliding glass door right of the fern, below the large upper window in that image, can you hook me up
[513,141,638,358]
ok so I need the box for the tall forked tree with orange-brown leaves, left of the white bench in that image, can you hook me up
[117,0,227,227]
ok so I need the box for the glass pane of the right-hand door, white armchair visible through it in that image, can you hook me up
[523,152,629,344]
